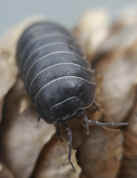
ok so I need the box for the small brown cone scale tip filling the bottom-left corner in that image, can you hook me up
[0,162,14,178]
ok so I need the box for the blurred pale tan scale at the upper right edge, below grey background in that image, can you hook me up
[93,9,137,61]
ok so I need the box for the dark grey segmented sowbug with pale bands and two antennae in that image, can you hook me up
[16,21,128,169]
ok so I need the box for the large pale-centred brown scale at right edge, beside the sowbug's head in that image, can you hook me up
[96,41,137,121]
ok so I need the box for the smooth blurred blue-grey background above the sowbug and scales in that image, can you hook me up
[0,0,137,34]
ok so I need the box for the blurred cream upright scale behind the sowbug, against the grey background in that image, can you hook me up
[73,9,109,61]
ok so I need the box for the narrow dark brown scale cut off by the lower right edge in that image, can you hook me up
[119,102,137,178]
